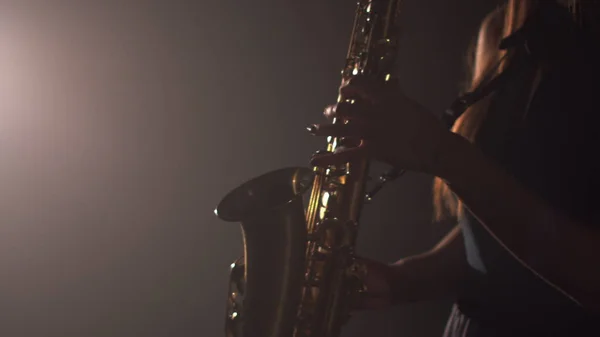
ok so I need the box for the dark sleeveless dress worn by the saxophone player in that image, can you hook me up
[444,3,600,337]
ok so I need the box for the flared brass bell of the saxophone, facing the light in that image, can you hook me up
[215,168,314,337]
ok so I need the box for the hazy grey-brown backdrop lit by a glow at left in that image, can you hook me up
[0,0,498,337]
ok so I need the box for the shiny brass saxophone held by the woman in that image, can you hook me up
[215,0,401,337]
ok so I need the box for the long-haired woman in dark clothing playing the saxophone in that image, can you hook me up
[311,0,600,337]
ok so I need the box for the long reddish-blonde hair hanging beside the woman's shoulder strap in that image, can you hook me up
[433,0,544,221]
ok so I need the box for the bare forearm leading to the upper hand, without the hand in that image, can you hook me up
[440,134,600,307]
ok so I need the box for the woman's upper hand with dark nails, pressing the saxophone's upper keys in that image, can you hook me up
[309,76,454,174]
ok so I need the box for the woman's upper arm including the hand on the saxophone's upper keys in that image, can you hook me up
[308,0,600,306]
